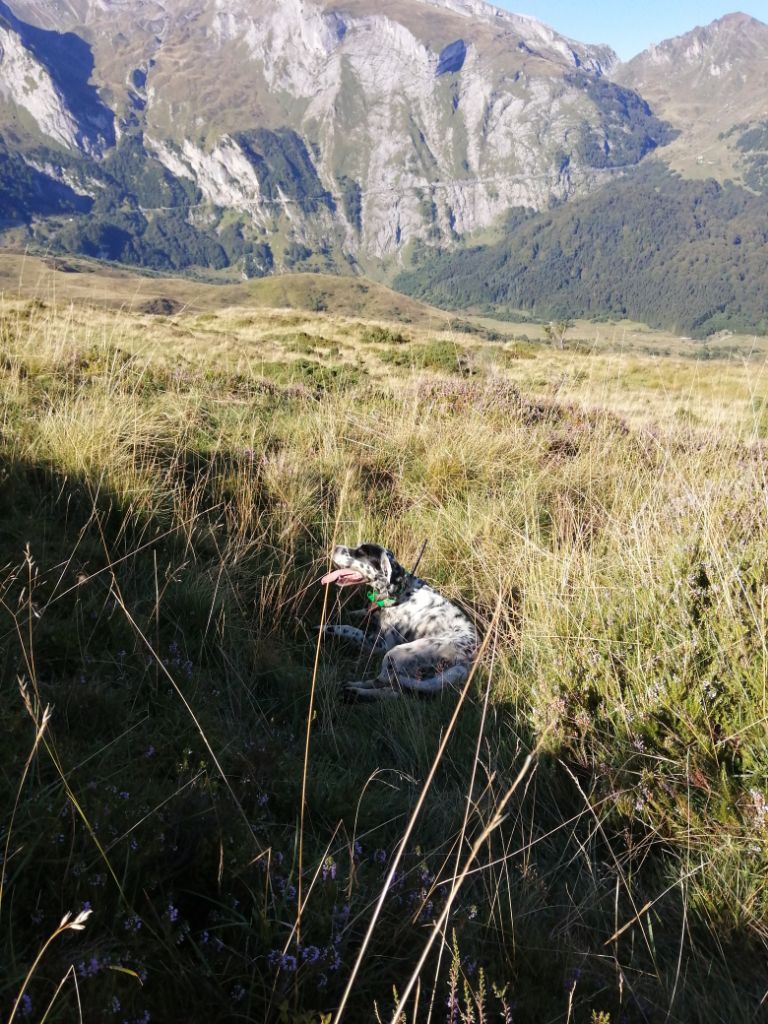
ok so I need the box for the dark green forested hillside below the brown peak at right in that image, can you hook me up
[395,163,768,338]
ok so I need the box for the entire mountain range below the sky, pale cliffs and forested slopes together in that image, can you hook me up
[0,0,768,335]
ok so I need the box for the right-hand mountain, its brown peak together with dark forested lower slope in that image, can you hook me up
[395,13,768,337]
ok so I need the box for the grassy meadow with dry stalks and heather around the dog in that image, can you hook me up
[0,264,768,1024]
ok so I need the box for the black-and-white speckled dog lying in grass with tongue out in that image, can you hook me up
[321,544,478,700]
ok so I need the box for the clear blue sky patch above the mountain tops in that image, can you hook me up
[490,0,768,60]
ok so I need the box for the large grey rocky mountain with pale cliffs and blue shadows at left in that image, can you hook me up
[0,0,675,274]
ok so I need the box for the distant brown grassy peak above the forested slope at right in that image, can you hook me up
[613,13,768,190]
